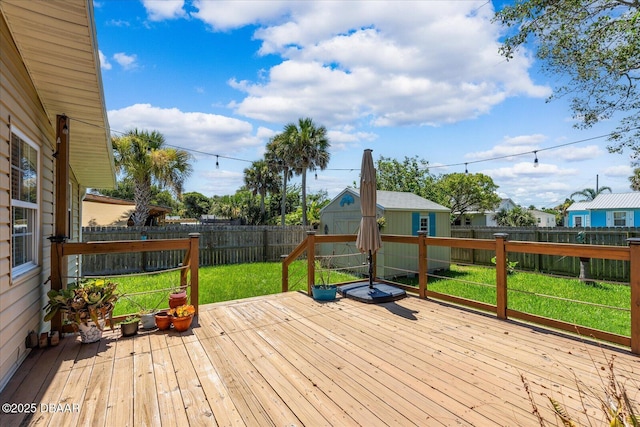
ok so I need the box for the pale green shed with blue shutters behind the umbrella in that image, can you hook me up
[318,188,451,278]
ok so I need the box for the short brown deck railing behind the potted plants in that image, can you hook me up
[51,233,200,330]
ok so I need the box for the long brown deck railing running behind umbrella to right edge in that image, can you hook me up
[282,231,640,354]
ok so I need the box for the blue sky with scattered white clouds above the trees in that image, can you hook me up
[94,0,632,208]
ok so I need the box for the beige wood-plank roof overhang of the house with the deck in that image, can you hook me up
[0,0,115,188]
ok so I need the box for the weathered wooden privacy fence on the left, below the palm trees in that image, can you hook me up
[82,225,311,276]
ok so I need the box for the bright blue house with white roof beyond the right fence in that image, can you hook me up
[567,192,640,227]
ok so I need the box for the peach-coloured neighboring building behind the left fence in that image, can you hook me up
[82,193,171,227]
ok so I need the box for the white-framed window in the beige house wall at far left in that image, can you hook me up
[9,126,42,278]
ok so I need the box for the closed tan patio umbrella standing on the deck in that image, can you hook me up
[356,149,382,288]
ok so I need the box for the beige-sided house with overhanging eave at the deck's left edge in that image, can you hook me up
[0,0,115,390]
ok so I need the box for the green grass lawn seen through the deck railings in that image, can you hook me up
[113,261,631,336]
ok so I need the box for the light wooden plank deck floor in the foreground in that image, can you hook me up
[0,292,640,427]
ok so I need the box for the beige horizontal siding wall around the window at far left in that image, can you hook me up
[0,15,70,390]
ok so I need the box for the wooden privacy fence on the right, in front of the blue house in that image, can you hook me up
[451,227,640,282]
